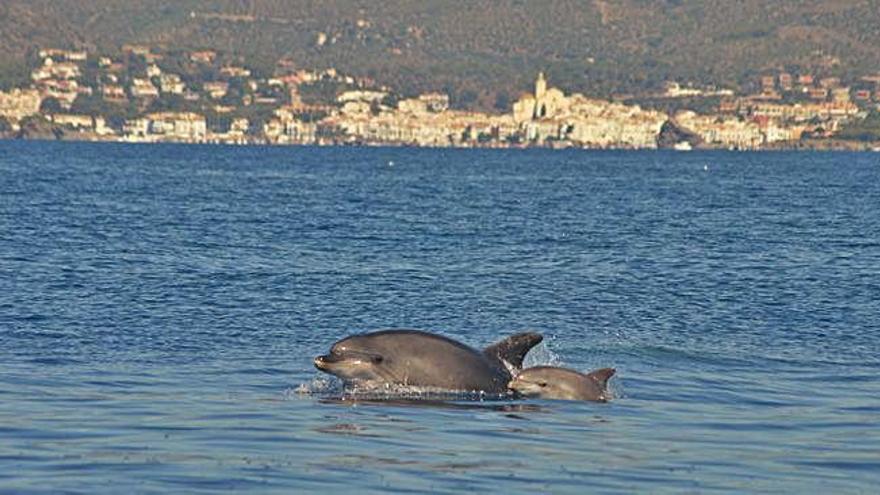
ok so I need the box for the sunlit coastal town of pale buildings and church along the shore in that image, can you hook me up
[0,45,880,150]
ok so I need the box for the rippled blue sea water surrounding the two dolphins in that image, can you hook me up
[0,141,880,494]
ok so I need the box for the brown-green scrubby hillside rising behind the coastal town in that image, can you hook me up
[0,0,880,108]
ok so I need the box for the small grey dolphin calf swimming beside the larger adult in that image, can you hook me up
[507,366,615,402]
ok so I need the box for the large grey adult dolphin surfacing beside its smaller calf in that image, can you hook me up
[315,330,544,394]
